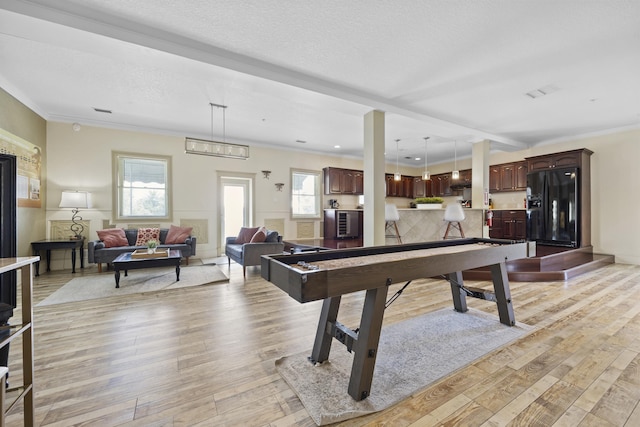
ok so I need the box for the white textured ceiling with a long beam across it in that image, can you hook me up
[0,0,640,166]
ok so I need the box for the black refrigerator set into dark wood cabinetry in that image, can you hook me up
[527,167,580,248]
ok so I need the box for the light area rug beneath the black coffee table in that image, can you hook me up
[36,265,229,306]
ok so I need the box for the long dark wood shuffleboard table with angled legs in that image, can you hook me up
[261,238,527,401]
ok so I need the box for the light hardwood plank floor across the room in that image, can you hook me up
[7,259,640,427]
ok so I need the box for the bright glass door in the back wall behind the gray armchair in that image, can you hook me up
[218,174,253,253]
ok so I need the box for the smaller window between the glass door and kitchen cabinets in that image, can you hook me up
[291,169,321,219]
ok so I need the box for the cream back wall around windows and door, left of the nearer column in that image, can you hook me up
[47,122,370,257]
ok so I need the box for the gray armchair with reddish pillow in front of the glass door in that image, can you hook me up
[224,227,284,277]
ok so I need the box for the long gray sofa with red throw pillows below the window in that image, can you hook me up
[87,226,196,273]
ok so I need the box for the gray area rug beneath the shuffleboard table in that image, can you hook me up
[276,309,533,426]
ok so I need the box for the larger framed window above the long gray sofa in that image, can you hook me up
[112,152,171,221]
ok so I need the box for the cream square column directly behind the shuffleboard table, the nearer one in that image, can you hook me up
[363,110,386,246]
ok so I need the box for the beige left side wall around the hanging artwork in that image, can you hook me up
[0,85,47,256]
